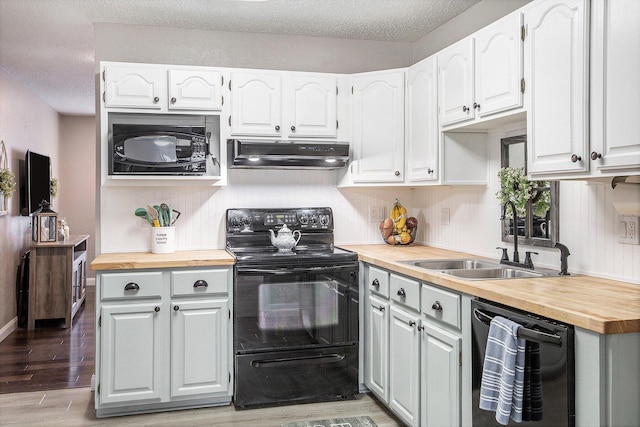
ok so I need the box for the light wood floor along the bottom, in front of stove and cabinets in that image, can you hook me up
[0,388,402,427]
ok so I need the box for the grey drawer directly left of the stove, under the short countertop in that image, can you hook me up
[171,269,230,296]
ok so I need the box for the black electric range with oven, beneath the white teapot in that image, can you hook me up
[226,208,359,408]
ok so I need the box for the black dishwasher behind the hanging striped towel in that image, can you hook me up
[471,300,575,427]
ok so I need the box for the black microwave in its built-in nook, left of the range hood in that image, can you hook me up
[109,114,219,175]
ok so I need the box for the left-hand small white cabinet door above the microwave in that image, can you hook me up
[103,66,167,110]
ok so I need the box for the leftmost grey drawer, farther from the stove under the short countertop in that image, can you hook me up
[101,271,162,300]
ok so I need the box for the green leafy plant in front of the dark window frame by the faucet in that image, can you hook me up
[496,167,551,218]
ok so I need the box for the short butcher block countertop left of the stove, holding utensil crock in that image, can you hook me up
[91,249,235,271]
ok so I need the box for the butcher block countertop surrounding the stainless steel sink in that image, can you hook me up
[340,244,640,334]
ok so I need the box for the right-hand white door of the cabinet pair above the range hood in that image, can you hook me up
[284,76,337,138]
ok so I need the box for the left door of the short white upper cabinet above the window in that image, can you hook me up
[438,37,476,126]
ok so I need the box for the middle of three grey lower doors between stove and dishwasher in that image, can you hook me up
[389,306,422,426]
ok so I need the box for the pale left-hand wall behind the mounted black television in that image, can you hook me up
[0,67,63,332]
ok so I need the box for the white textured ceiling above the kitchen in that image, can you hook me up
[0,0,479,114]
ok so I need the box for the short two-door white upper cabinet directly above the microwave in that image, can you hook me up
[103,64,223,111]
